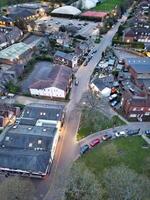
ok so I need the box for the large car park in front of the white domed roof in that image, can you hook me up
[36,17,98,37]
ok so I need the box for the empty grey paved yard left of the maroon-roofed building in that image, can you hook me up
[21,61,53,93]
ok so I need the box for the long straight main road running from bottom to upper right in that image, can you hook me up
[36,12,129,200]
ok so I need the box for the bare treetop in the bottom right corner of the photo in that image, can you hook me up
[103,165,150,200]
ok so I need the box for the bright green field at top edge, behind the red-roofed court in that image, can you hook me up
[94,0,122,12]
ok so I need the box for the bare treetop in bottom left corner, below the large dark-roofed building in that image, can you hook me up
[0,177,35,200]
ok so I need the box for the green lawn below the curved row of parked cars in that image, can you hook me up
[78,136,150,178]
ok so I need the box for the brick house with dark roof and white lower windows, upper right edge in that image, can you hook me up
[123,26,150,43]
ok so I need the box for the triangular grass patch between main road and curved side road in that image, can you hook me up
[77,110,125,140]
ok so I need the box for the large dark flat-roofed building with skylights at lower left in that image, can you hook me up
[0,104,64,178]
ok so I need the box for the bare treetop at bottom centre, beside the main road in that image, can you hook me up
[65,164,102,200]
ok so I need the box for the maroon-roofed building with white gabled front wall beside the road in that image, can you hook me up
[29,65,72,99]
